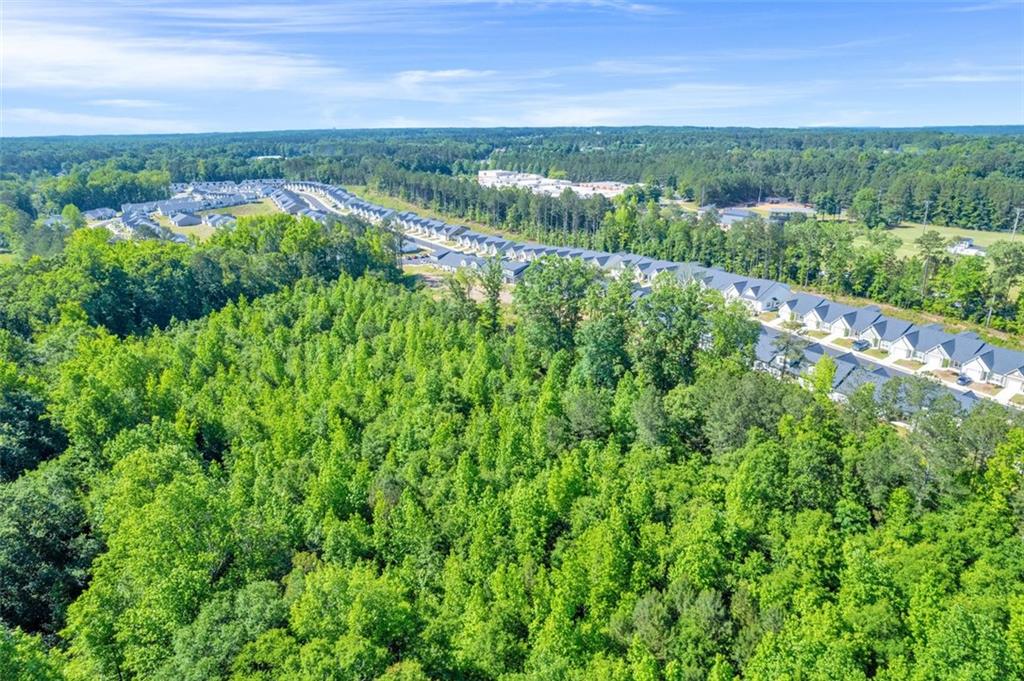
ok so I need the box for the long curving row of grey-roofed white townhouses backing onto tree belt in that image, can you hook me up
[276,183,1024,400]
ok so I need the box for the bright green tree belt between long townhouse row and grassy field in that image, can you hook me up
[481,199,1024,342]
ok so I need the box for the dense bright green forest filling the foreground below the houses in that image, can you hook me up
[0,208,1024,681]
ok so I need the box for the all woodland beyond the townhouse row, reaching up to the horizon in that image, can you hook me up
[8,128,1024,334]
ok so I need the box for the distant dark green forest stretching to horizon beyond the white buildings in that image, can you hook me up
[0,128,1024,229]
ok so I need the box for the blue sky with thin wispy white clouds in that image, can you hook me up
[0,0,1024,136]
